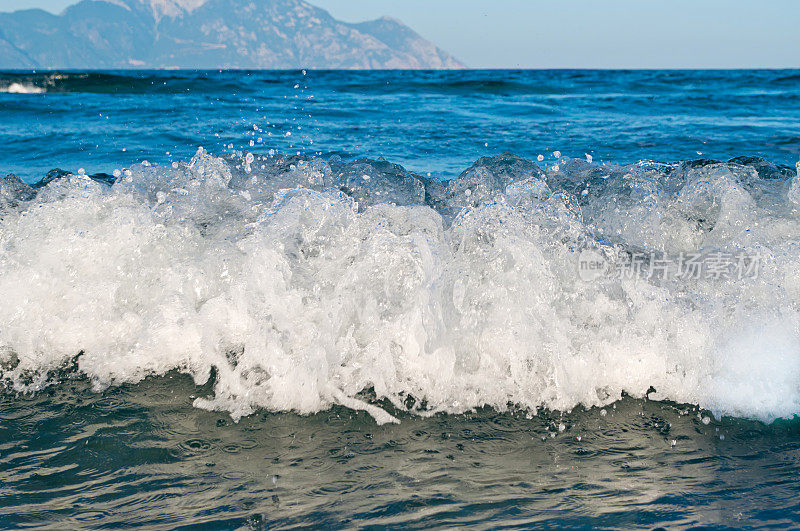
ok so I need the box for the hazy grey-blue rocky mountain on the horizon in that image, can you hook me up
[0,0,464,69]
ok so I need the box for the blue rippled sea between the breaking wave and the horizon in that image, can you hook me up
[0,70,800,181]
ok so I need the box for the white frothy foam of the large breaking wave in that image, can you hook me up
[0,150,800,422]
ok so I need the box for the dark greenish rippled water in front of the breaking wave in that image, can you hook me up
[0,376,800,529]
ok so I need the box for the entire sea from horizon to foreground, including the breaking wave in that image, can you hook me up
[0,70,800,529]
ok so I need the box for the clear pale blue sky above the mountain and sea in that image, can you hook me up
[0,0,800,68]
